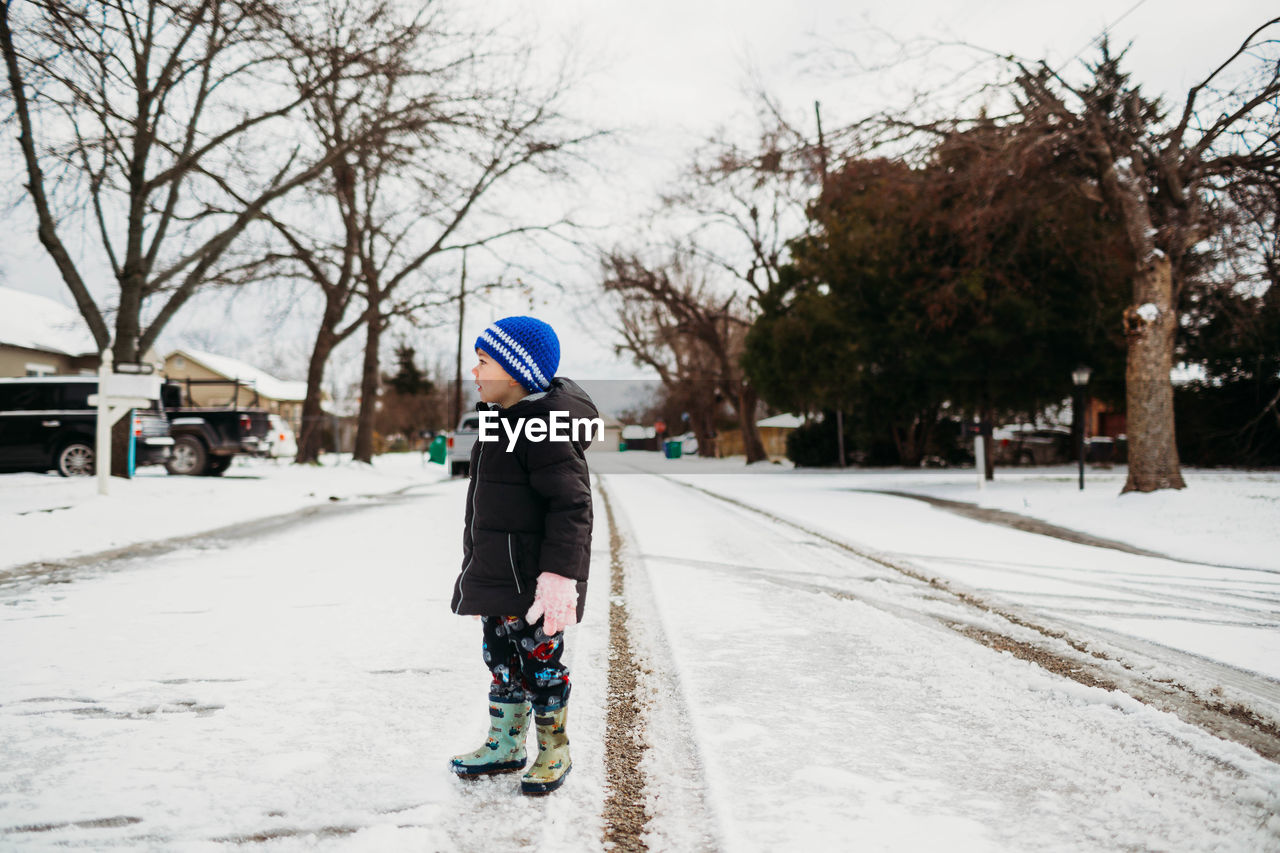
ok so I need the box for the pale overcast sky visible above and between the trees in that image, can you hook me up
[0,0,1276,399]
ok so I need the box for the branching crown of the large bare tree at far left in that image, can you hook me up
[0,0,399,362]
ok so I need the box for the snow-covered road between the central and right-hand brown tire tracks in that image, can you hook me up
[605,474,1280,850]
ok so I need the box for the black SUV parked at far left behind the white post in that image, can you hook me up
[0,377,173,476]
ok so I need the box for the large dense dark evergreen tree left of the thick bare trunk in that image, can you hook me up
[744,124,1128,465]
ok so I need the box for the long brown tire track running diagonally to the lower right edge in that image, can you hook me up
[653,474,1280,762]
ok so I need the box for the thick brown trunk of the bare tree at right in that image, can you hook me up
[1124,257,1187,492]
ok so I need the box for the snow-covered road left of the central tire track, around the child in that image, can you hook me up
[0,480,608,850]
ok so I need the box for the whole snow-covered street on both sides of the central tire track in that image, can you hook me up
[0,466,1280,850]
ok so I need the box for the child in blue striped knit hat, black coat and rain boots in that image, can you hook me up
[451,316,599,794]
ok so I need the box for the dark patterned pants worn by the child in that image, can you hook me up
[480,616,570,713]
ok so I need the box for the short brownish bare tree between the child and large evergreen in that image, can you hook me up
[603,252,768,464]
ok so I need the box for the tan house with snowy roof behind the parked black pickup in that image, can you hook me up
[163,348,307,432]
